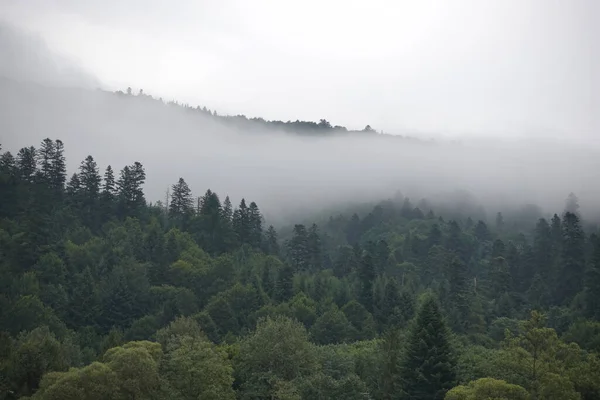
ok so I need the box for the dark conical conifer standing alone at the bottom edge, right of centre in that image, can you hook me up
[401,297,456,400]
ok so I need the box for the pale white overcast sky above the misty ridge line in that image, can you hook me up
[0,0,600,140]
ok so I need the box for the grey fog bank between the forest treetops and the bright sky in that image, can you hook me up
[0,14,600,225]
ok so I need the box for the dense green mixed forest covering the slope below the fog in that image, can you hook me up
[0,139,600,400]
